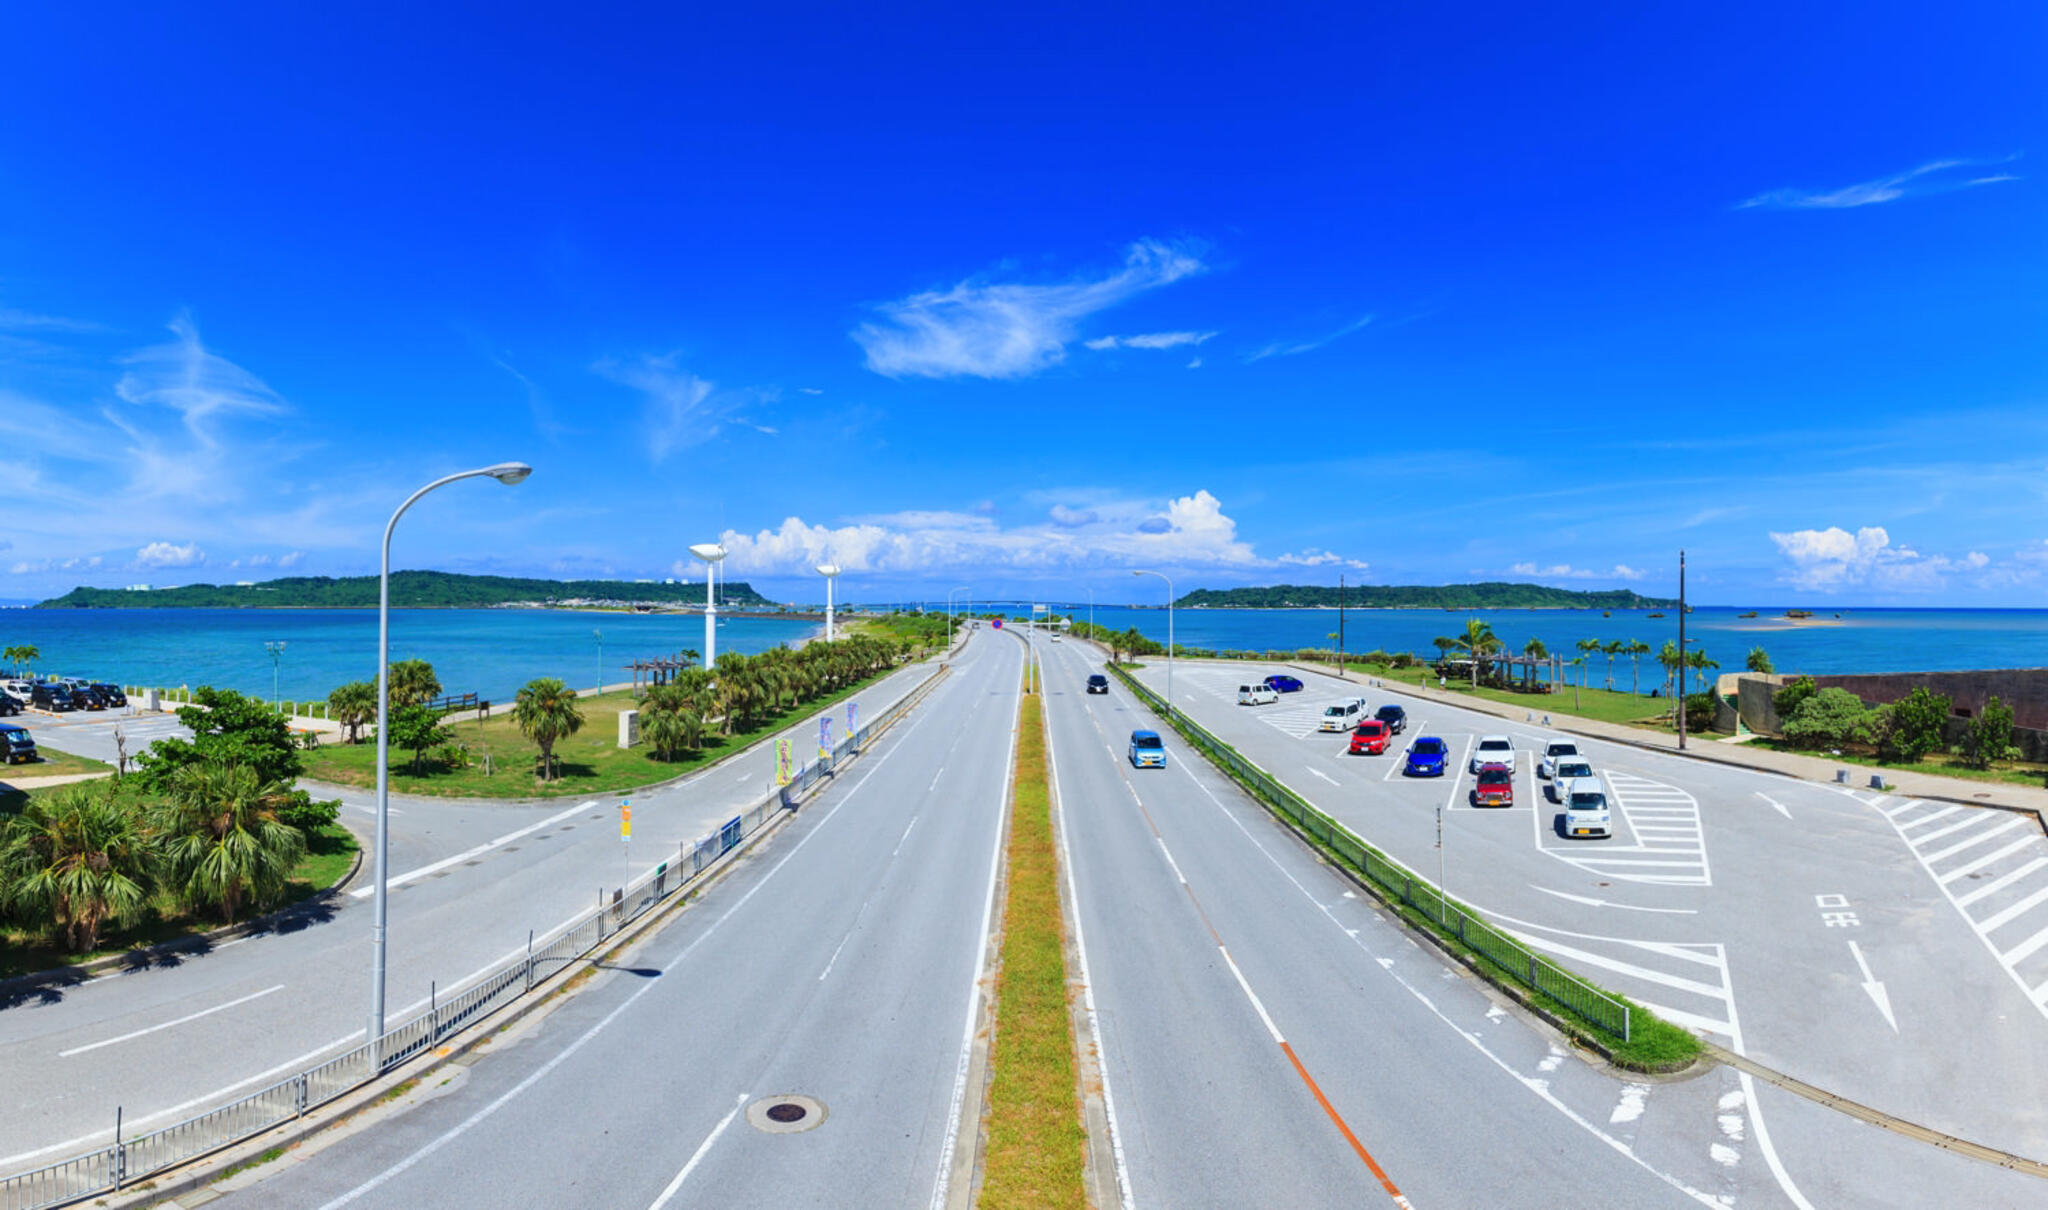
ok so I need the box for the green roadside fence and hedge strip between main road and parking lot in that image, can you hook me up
[1110,663,1634,1042]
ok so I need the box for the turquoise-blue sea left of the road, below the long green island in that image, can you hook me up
[0,608,819,702]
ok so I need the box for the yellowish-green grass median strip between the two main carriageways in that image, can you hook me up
[979,694,1087,1208]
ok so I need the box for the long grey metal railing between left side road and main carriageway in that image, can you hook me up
[0,667,950,1210]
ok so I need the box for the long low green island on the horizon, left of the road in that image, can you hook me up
[35,571,776,610]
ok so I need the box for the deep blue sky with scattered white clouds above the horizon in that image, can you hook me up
[0,2,2048,606]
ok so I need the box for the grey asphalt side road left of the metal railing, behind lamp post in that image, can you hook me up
[0,663,938,1171]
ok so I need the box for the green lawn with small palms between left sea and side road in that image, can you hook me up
[305,672,905,798]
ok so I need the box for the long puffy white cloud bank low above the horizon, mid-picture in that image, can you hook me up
[721,491,1364,573]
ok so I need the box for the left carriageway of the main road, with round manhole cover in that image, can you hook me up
[192,635,1022,1208]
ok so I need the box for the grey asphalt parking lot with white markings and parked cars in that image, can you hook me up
[1096,661,2048,1206]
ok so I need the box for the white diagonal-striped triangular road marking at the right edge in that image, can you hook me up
[1851,794,2048,1015]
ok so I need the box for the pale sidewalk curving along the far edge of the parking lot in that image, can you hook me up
[1290,665,2048,829]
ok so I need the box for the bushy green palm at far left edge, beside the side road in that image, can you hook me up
[0,782,154,954]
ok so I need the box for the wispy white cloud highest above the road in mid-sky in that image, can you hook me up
[852,240,1202,379]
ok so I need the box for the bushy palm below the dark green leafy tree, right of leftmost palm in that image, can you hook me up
[152,762,305,923]
